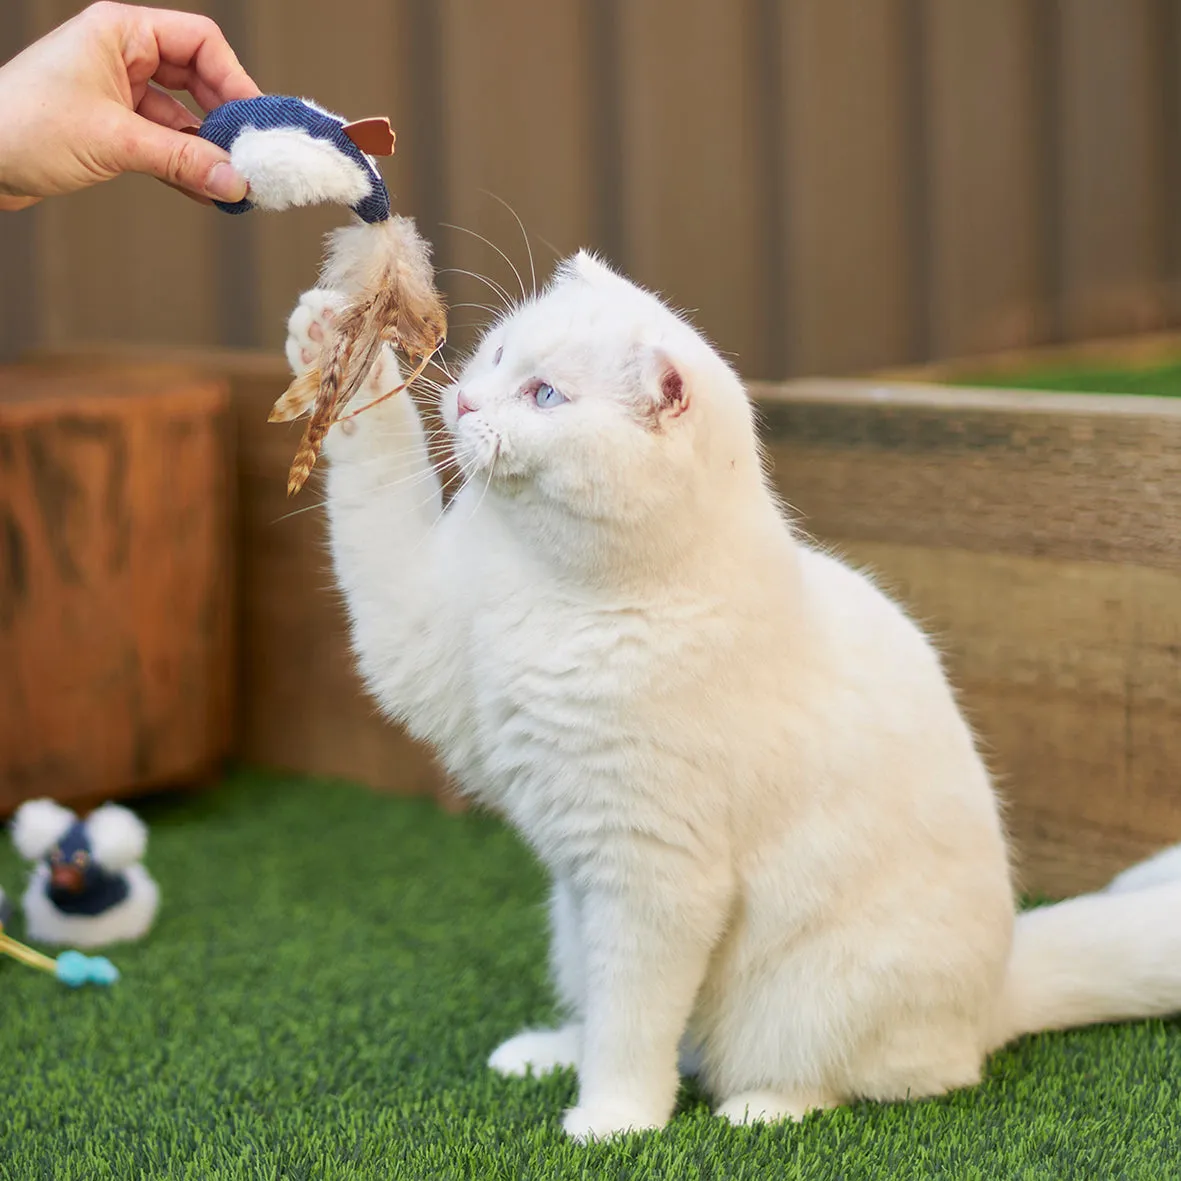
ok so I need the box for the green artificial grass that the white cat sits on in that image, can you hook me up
[0,774,1181,1181]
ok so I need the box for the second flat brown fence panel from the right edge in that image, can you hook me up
[925,0,1052,357]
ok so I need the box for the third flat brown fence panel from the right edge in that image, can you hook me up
[783,0,922,373]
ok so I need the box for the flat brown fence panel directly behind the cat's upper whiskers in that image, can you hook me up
[437,0,595,346]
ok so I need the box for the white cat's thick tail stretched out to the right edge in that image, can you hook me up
[992,846,1181,1046]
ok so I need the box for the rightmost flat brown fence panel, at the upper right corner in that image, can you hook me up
[1061,0,1177,338]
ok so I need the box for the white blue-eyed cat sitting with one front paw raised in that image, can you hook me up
[288,253,1181,1140]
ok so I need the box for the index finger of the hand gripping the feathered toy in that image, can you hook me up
[128,8,261,111]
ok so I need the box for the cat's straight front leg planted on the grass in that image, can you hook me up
[562,849,729,1141]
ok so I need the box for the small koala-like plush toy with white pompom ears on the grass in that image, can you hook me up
[13,800,159,947]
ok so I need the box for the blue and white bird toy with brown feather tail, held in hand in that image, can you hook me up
[196,94,446,496]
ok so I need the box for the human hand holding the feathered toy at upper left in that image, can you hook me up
[0,2,260,209]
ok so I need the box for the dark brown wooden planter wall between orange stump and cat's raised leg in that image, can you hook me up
[24,345,457,808]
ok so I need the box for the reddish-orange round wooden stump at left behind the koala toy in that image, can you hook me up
[0,366,233,813]
